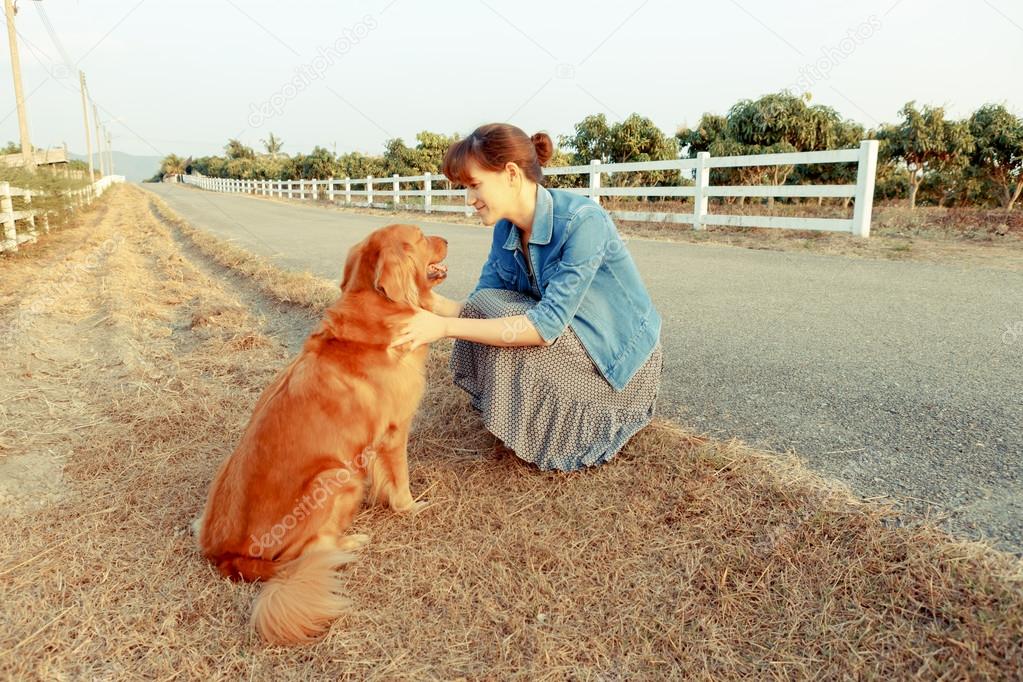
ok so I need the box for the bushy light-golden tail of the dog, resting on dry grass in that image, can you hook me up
[251,550,355,644]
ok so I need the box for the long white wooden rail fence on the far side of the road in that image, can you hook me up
[181,140,878,237]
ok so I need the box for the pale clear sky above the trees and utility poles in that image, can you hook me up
[0,0,1023,155]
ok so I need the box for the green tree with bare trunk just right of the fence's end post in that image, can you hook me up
[878,101,974,209]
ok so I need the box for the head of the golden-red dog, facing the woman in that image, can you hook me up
[341,225,447,308]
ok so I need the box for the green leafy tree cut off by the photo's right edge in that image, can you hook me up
[970,104,1023,211]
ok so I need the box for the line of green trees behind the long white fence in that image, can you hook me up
[160,92,1023,210]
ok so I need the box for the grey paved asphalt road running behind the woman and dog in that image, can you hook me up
[144,185,1023,556]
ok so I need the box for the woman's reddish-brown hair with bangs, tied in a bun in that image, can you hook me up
[443,123,554,185]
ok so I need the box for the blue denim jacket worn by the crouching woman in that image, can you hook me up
[470,185,661,391]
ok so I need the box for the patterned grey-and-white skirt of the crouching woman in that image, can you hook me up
[451,288,662,471]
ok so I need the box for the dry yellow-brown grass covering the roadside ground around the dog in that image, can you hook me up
[0,186,1023,680]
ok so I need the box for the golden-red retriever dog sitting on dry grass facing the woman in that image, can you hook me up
[193,225,447,644]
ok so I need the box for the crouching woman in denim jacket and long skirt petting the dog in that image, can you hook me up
[393,124,661,470]
